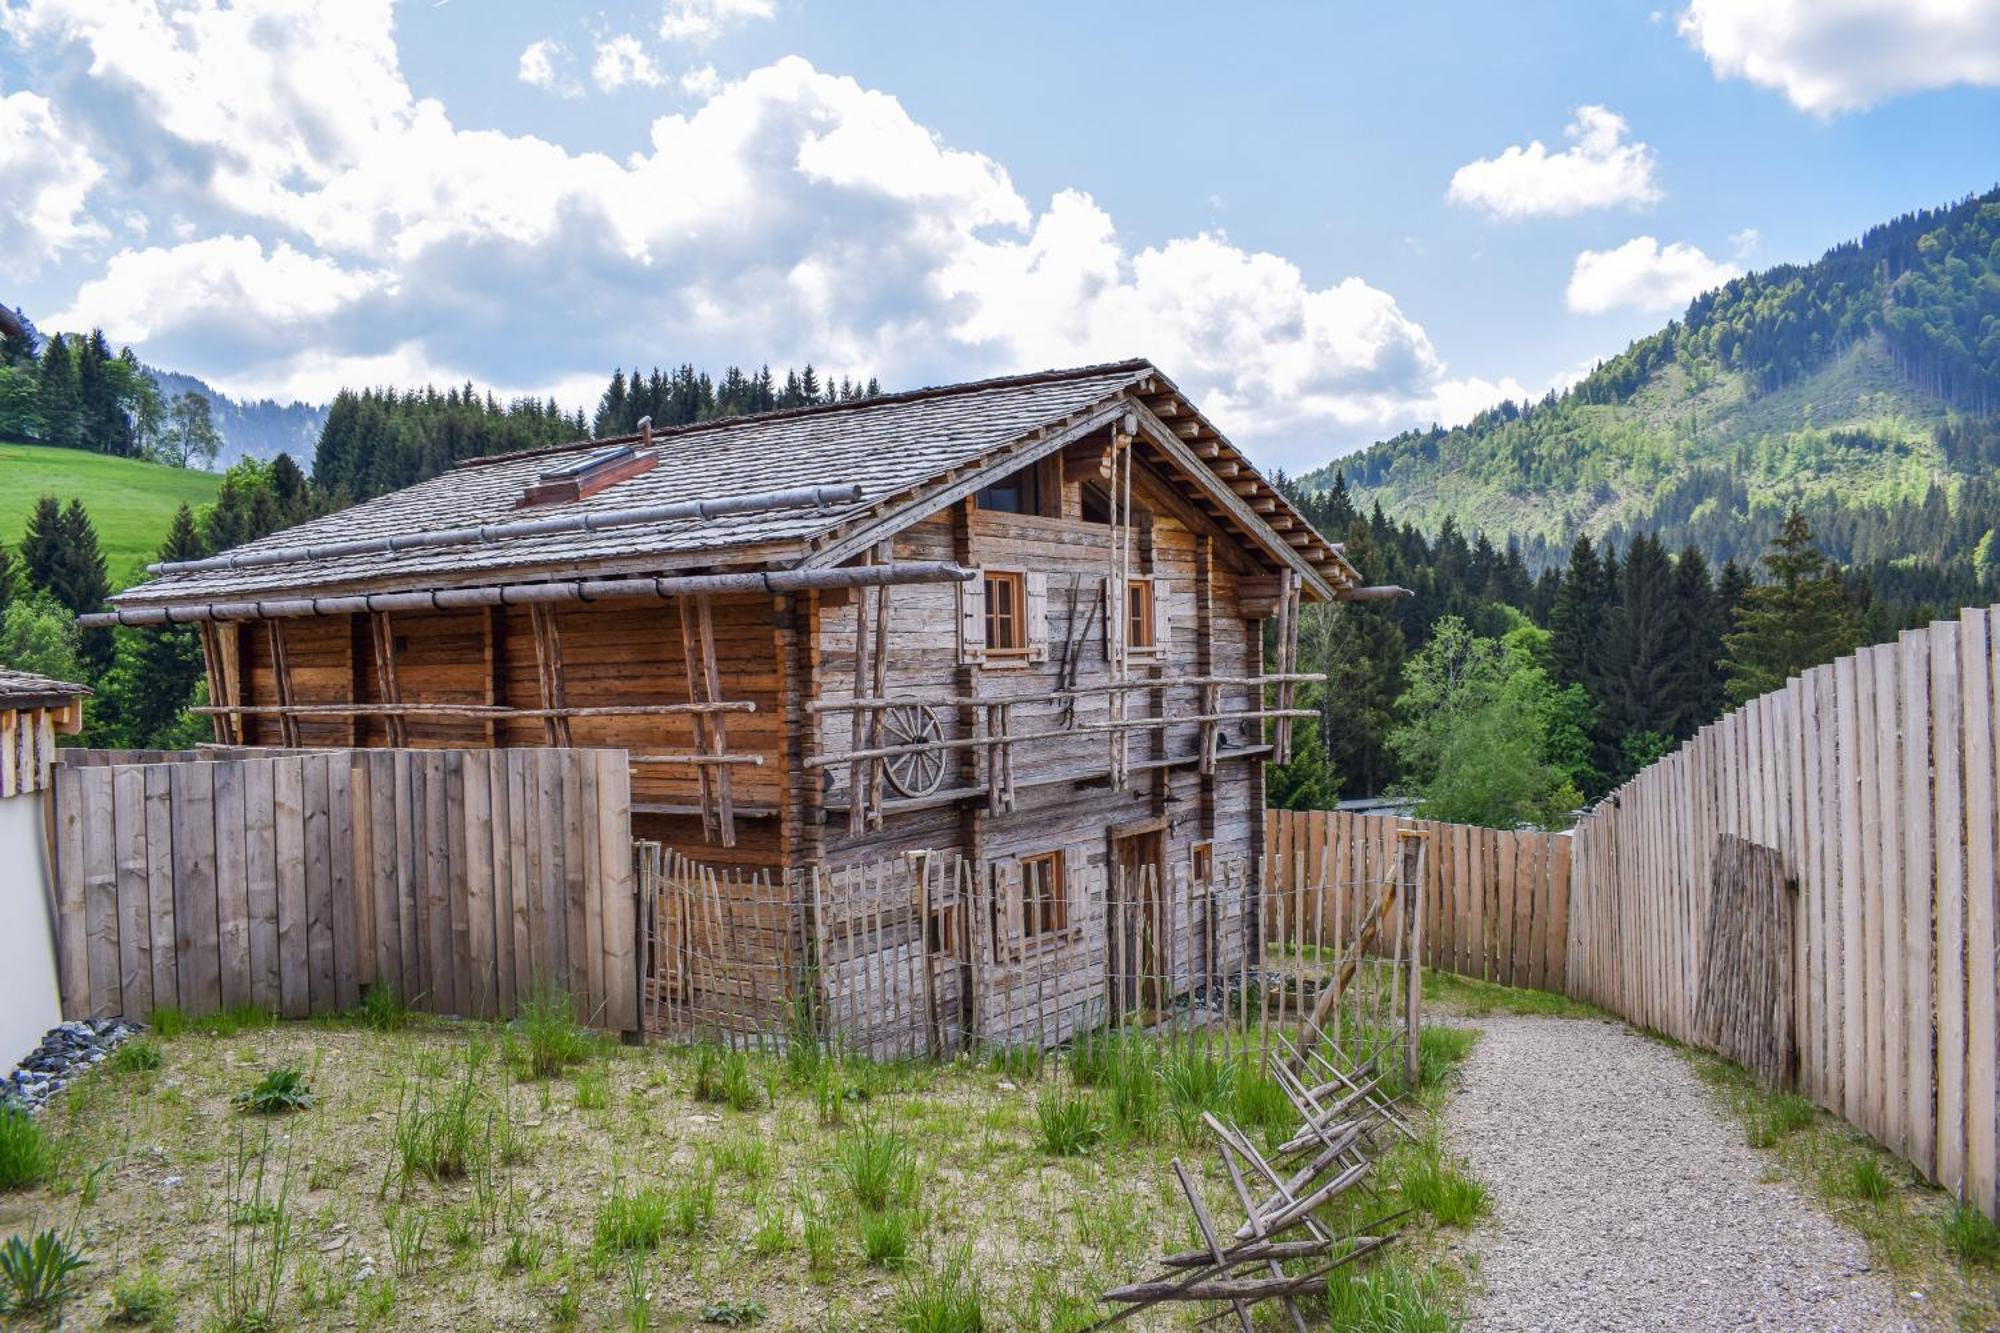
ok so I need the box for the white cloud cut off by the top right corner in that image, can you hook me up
[1680,0,2000,116]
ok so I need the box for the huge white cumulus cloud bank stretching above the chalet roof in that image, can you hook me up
[7,0,1524,466]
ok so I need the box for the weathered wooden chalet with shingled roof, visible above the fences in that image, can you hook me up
[96,360,1394,1048]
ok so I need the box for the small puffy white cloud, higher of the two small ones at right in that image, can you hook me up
[1444,106,1662,218]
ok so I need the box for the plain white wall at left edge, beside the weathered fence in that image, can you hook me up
[0,793,62,1073]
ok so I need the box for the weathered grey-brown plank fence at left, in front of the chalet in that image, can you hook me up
[52,749,640,1031]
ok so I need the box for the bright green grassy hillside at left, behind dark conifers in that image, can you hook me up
[0,444,222,588]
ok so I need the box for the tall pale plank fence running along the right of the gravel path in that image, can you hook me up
[1568,608,2000,1215]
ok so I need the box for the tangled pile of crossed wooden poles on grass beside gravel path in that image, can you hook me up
[1094,1037,1414,1333]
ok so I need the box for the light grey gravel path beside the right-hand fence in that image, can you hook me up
[1446,1017,1918,1333]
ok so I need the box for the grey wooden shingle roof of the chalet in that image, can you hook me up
[112,360,1360,608]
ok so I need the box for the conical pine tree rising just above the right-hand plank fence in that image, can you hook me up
[1724,504,1860,705]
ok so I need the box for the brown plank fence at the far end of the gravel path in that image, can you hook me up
[1264,811,1570,993]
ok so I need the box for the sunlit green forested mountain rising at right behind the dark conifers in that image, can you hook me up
[1298,190,2000,580]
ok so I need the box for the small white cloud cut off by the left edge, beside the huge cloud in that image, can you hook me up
[0,82,108,266]
